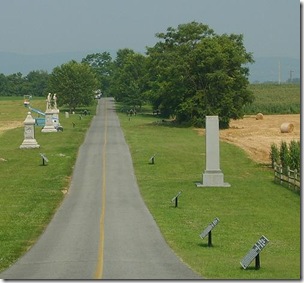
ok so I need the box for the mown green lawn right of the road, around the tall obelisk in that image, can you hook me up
[119,110,300,279]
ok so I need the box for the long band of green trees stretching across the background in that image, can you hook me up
[0,22,254,128]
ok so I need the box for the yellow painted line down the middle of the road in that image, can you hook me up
[94,100,108,279]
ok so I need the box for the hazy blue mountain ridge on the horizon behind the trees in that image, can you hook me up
[0,50,300,82]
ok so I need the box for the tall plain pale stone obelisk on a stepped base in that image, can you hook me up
[197,116,230,187]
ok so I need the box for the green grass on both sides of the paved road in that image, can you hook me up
[0,87,300,279]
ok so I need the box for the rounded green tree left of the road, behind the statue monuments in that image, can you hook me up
[49,60,98,112]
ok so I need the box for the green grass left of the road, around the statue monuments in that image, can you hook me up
[0,98,95,271]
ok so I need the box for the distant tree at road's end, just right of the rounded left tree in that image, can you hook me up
[81,52,113,95]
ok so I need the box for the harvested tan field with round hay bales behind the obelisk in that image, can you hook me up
[199,114,300,163]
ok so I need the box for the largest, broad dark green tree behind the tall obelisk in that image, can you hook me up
[147,22,254,128]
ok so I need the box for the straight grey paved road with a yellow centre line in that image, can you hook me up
[0,98,200,279]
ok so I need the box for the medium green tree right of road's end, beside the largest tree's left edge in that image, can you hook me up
[110,48,146,108]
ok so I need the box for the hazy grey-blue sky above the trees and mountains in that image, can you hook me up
[0,0,300,58]
